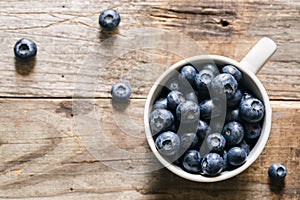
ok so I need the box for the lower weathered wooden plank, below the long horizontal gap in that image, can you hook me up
[0,99,300,199]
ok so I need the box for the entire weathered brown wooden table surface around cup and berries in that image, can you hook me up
[0,0,300,200]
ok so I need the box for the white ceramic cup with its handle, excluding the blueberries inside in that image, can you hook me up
[144,37,277,182]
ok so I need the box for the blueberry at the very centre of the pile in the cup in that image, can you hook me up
[199,99,223,120]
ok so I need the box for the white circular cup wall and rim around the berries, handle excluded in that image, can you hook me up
[144,55,272,182]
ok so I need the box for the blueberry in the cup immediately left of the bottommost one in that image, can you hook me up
[182,150,201,173]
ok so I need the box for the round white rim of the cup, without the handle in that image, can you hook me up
[144,55,272,182]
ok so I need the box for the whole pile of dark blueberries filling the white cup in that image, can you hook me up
[149,63,265,177]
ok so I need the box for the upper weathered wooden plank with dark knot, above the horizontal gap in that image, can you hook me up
[0,0,300,100]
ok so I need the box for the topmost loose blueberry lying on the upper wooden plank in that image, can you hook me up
[99,9,121,31]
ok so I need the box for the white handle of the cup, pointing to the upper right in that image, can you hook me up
[240,37,277,74]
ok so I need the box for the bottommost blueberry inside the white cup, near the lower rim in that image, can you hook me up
[201,153,225,176]
